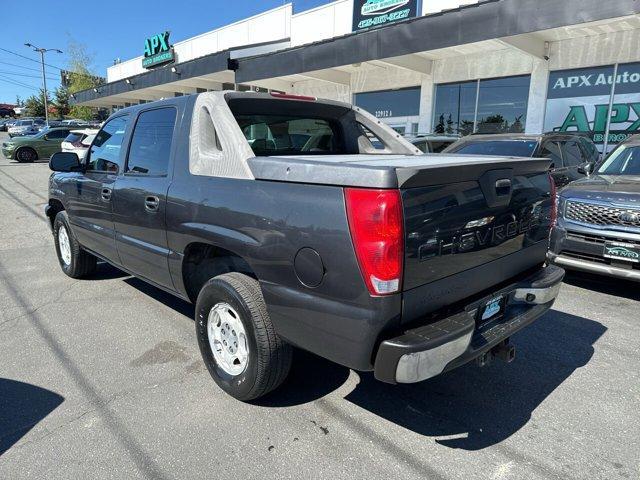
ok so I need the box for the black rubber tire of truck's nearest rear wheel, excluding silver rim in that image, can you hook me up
[195,273,292,401]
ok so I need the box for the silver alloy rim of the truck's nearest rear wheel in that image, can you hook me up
[207,302,249,376]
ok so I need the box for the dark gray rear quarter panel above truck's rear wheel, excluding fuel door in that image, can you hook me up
[167,171,400,370]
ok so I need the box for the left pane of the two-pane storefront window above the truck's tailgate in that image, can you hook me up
[434,82,478,135]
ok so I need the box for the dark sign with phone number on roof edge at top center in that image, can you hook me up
[353,0,418,32]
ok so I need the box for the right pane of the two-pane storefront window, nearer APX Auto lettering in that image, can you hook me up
[476,75,531,133]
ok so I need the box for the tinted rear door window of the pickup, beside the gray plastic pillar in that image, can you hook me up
[125,107,176,175]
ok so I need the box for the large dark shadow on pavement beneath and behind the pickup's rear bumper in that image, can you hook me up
[260,311,607,450]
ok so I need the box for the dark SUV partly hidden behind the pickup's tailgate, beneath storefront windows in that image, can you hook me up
[444,133,600,188]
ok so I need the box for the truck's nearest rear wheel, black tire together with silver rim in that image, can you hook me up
[195,273,292,401]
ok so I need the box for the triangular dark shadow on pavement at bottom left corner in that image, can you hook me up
[0,378,64,456]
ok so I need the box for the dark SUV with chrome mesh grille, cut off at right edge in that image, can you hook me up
[549,135,640,281]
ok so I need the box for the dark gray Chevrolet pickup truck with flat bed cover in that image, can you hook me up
[46,92,564,401]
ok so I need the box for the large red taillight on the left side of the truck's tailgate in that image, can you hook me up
[345,188,404,295]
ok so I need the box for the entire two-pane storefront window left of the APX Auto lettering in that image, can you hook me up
[434,75,531,135]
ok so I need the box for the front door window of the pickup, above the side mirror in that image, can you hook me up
[87,115,129,173]
